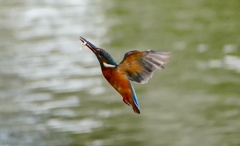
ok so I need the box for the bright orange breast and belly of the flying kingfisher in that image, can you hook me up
[102,68,132,98]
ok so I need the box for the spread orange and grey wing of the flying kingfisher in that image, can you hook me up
[117,50,170,84]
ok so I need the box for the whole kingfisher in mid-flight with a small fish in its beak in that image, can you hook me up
[79,37,171,114]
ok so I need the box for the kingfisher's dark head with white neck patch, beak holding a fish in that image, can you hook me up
[79,37,118,68]
